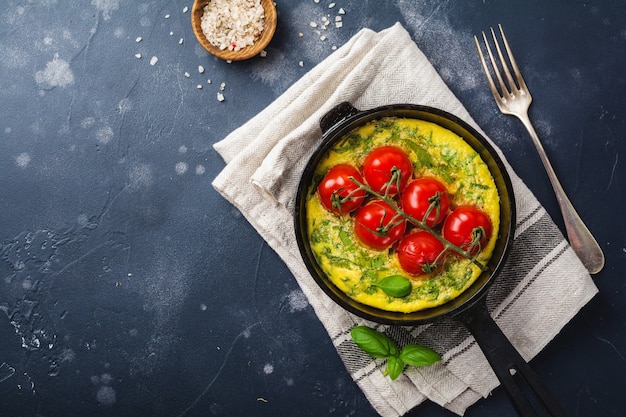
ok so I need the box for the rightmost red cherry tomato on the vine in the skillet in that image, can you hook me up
[442,206,492,256]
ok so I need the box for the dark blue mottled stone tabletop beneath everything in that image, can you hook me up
[0,0,626,417]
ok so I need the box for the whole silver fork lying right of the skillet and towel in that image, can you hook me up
[474,25,604,274]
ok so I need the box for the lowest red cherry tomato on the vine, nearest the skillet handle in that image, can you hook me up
[396,230,445,276]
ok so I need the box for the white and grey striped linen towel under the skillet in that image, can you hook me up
[213,24,597,417]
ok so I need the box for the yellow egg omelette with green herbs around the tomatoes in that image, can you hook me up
[306,117,500,313]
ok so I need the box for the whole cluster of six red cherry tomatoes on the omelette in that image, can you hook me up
[317,146,492,276]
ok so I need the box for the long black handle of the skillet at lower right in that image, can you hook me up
[458,299,566,417]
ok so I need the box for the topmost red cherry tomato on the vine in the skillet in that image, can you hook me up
[363,146,413,195]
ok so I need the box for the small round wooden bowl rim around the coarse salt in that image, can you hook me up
[191,0,277,61]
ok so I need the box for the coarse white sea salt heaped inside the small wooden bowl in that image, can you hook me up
[200,0,265,51]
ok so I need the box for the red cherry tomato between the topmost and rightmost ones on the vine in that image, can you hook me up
[401,177,450,227]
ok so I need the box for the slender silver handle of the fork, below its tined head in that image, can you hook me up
[519,114,604,274]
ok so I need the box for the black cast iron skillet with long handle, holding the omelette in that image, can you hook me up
[295,103,565,416]
